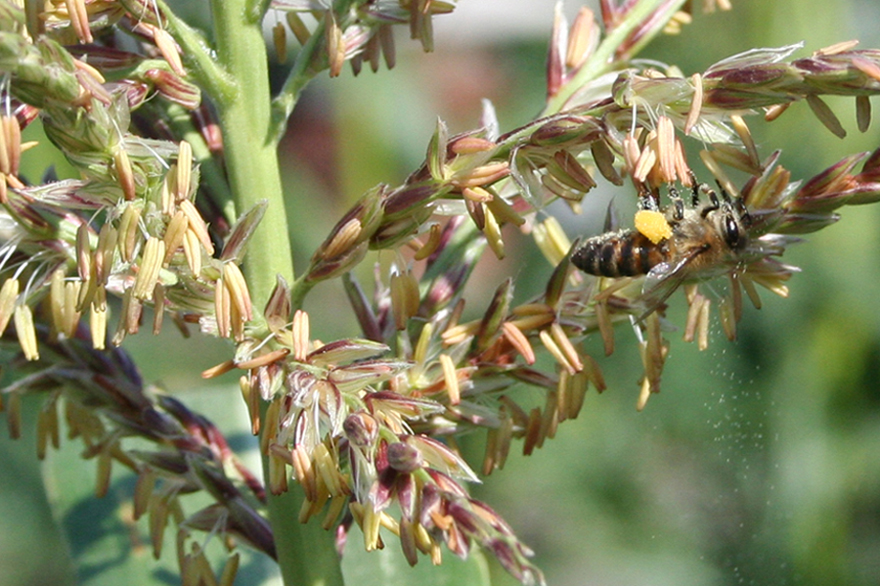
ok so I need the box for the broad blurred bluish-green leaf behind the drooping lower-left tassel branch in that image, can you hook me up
[36,385,280,586]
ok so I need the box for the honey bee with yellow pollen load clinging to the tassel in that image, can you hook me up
[571,182,751,304]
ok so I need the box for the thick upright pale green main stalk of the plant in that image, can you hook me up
[211,0,343,586]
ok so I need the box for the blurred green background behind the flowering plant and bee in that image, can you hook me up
[0,0,880,586]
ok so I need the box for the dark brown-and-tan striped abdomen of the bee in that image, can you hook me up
[571,230,667,277]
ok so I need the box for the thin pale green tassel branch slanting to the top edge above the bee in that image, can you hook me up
[541,0,685,116]
